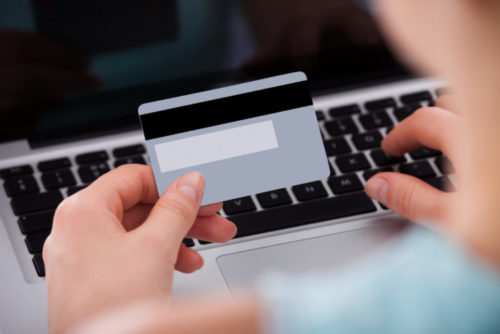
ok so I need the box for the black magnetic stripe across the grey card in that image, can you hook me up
[140,77,313,140]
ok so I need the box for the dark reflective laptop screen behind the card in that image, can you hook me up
[0,0,408,146]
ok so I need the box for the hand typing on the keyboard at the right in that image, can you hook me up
[366,99,460,227]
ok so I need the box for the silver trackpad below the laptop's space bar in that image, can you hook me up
[217,220,404,292]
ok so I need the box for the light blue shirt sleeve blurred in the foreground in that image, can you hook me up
[260,227,500,334]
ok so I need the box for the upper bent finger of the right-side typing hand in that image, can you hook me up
[382,107,458,160]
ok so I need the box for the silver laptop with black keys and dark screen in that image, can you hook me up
[0,0,454,333]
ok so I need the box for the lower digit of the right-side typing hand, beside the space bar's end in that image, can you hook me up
[365,172,451,224]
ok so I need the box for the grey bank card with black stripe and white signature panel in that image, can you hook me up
[139,72,330,205]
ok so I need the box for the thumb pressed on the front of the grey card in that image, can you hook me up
[141,172,205,254]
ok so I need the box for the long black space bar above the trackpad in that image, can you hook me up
[231,193,376,238]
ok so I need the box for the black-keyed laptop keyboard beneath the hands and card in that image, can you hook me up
[0,91,452,277]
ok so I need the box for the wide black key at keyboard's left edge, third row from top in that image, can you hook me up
[10,190,63,216]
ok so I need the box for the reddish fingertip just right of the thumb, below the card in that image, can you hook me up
[187,215,236,243]
